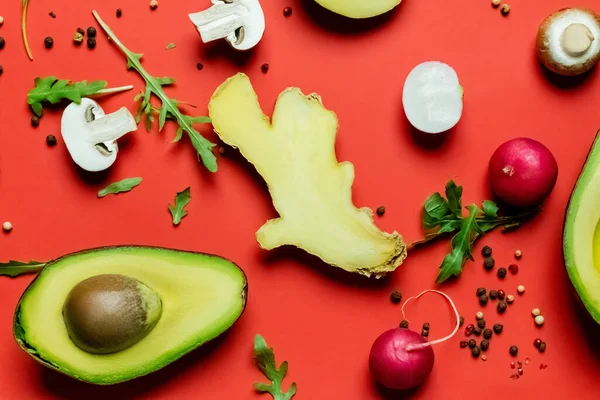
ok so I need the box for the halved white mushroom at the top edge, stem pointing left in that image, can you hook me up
[189,0,265,50]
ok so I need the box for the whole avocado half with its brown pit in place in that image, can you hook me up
[13,246,248,385]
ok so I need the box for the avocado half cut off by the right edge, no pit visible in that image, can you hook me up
[563,131,600,324]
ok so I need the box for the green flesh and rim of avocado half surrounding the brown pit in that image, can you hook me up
[13,246,247,385]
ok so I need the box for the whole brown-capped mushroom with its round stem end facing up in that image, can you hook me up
[536,8,600,76]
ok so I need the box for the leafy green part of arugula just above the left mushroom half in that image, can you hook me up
[27,76,108,117]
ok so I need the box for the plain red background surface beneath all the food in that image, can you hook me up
[0,0,600,400]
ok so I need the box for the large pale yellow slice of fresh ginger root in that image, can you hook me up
[208,73,406,277]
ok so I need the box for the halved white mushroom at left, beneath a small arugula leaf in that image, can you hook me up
[61,98,137,172]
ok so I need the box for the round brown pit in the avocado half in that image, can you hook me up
[63,274,162,354]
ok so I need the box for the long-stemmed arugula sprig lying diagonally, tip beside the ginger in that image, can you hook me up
[92,10,217,172]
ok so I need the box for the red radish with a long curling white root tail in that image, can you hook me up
[369,289,460,390]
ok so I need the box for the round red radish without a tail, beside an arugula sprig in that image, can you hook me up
[489,138,558,207]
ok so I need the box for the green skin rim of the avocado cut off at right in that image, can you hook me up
[562,130,600,325]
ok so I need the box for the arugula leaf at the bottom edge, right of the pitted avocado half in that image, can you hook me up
[253,335,296,400]
